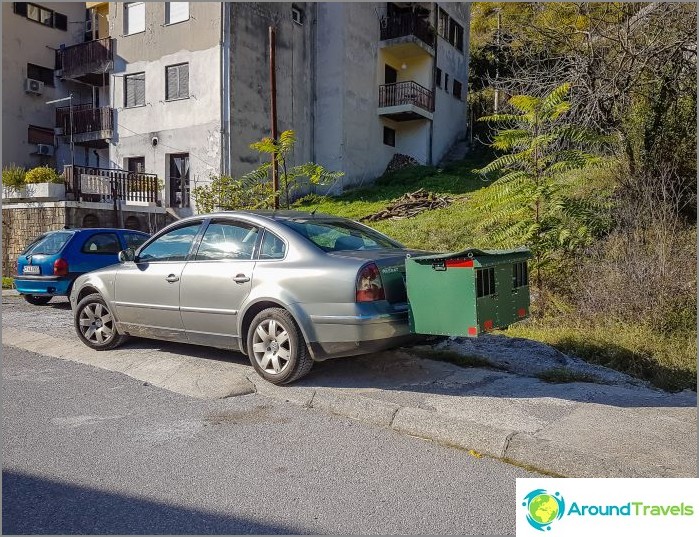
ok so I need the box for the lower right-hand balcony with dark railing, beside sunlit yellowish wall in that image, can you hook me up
[378,81,434,121]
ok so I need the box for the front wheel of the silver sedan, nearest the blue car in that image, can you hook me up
[73,293,127,351]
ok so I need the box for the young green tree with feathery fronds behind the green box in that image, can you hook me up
[474,83,608,314]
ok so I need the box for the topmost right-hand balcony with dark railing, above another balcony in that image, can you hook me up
[380,13,435,59]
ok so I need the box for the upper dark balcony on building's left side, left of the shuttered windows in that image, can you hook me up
[56,37,114,86]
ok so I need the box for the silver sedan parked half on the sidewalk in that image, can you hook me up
[70,211,424,384]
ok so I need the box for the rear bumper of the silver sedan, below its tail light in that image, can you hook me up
[309,310,413,361]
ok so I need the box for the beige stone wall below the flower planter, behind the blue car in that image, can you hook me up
[2,206,66,276]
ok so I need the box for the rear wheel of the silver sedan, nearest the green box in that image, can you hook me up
[247,308,313,384]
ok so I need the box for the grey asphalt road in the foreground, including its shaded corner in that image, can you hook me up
[2,347,532,534]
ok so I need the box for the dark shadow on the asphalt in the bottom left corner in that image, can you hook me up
[2,470,309,535]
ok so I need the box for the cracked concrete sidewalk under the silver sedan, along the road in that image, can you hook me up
[2,325,697,477]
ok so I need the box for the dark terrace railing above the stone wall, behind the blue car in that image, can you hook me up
[64,166,161,205]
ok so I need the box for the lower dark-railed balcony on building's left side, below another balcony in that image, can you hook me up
[56,104,114,148]
